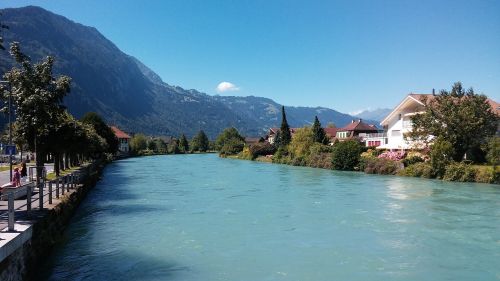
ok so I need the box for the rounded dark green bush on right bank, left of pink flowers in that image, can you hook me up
[332,140,363,171]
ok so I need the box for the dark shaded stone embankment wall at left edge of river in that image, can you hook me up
[0,160,105,281]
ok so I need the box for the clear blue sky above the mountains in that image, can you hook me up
[0,0,500,112]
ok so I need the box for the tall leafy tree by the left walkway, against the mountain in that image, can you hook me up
[2,42,71,182]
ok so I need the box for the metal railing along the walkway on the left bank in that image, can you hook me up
[0,164,93,231]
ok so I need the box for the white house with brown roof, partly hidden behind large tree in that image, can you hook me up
[365,93,500,150]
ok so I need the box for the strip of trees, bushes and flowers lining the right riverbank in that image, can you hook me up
[216,83,500,184]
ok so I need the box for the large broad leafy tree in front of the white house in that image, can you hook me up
[409,82,499,161]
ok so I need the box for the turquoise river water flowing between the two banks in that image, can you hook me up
[41,154,500,281]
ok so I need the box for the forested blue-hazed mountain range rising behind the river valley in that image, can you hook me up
[0,6,378,139]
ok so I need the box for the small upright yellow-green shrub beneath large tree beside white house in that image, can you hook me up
[429,137,455,178]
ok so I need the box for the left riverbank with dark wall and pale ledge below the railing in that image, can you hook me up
[0,162,105,281]
